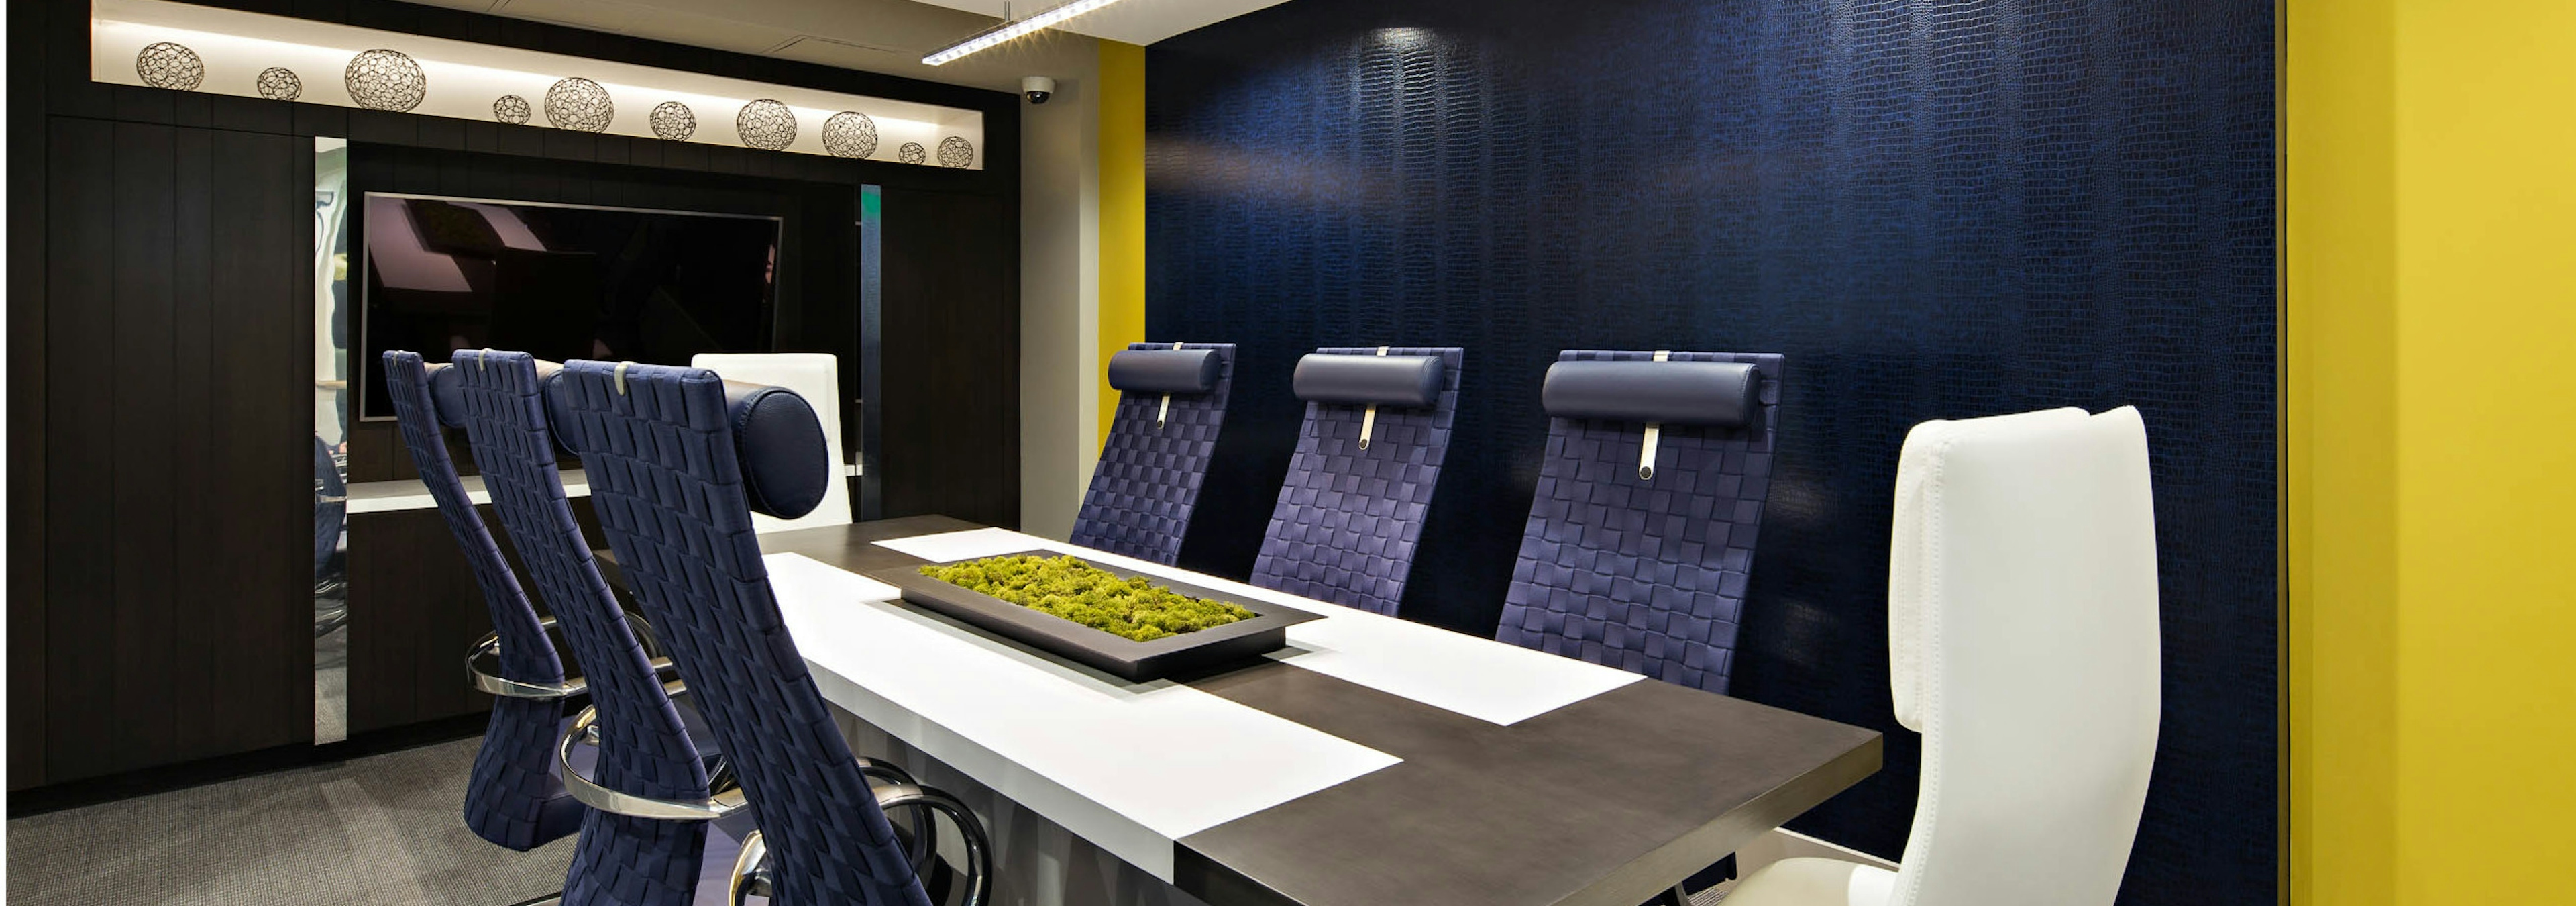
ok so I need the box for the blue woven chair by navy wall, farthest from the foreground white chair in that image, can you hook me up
[1071,342,1234,566]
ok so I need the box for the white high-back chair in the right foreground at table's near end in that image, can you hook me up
[1726,407,2161,906]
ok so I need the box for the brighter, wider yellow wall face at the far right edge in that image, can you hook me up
[2396,0,2576,903]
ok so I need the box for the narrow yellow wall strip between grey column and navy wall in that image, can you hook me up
[1092,41,1144,443]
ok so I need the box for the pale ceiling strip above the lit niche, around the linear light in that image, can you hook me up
[410,0,1283,93]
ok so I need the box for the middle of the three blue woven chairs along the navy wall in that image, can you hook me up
[1252,348,1466,615]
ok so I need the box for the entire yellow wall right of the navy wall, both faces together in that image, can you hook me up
[2282,0,2576,906]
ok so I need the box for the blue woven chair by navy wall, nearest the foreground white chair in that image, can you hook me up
[1494,350,1785,693]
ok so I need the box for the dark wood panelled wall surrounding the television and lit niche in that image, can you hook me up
[8,0,1020,790]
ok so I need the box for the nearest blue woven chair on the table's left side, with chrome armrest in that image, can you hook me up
[549,360,991,906]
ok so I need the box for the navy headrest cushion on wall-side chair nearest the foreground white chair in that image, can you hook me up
[1538,363,1762,427]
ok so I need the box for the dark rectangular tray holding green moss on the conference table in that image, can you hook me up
[863,551,1324,682]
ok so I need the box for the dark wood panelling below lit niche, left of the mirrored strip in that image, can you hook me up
[25,118,312,785]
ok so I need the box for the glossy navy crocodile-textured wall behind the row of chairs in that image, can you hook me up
[1146,0,2277,903]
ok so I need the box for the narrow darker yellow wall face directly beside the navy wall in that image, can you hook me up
[2279,0,2401,906]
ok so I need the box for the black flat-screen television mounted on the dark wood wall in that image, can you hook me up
[358,193,778,419]
